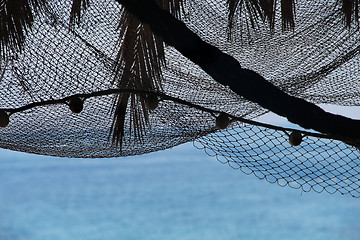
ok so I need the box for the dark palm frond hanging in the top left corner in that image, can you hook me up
[0,0,46,57]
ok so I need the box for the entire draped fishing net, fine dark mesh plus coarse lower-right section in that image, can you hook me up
[0,0,360,197]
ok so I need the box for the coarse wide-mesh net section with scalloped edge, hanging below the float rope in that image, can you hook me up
[195,124,360,197]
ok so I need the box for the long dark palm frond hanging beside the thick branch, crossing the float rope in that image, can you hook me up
[112,0,184,150]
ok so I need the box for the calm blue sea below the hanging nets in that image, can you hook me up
[0,144,360,240]
